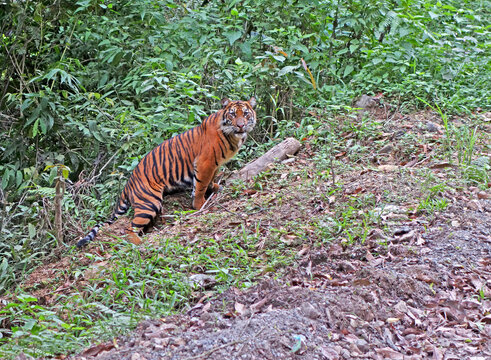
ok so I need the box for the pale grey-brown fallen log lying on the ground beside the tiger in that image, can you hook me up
[231,138,301,180]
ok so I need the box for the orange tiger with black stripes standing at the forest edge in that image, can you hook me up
[77,97,256,248]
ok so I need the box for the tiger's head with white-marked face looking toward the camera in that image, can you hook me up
[220,97,256,139]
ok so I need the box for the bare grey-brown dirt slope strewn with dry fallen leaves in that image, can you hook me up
[71,110,491,360]
